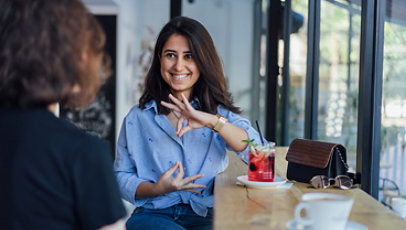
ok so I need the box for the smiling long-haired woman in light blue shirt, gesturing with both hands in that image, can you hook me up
[115,17,260,230]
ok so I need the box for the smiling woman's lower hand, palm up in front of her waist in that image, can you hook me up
[155,161,206,195]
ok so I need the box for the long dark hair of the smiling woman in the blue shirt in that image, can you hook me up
[139,16,240,114]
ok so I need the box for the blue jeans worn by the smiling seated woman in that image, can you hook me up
[126,204,213,230]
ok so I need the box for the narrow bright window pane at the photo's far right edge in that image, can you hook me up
[380,1,406,210]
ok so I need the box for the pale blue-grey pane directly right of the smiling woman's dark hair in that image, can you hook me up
[182,0,254,121]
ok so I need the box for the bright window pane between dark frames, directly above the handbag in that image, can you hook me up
[317,0,361,170]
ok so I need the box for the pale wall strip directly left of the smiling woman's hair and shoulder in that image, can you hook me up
[114,0,170,141]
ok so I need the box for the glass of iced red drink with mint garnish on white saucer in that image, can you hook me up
[248,143,275,182]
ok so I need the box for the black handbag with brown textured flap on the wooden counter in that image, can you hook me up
[286,139,348,183]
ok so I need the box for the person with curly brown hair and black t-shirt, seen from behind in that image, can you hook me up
[0,0,126,230]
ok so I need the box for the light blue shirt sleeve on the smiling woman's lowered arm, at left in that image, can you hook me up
[114,118,147,206]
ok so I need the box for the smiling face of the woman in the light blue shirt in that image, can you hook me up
[160,34,200,98]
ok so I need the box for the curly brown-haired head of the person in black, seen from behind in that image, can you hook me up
[0,0,109,109]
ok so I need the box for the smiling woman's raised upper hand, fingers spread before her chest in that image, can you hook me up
[161,94,216,137]
